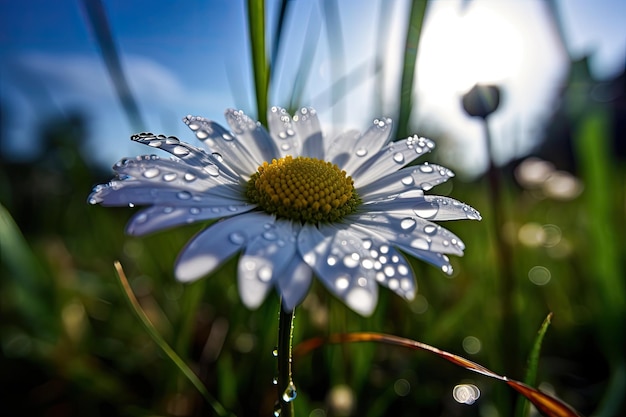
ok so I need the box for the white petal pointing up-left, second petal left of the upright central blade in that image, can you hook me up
[183,116,262,179]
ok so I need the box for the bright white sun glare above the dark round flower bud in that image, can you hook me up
[418,3,522,95]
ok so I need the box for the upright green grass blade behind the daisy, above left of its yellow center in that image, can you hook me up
[248,0,269,127]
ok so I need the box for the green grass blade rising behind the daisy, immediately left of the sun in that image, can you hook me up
[397,0,427,137]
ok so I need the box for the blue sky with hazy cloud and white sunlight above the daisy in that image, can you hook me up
[0,0,626,175]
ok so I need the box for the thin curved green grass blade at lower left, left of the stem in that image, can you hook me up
[115,262,230,416]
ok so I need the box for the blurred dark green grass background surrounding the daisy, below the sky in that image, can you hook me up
[0,1,626,417]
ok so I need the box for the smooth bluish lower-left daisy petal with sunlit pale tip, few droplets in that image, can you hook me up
[174,212,274,282]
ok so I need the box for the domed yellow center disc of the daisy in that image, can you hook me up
[246,155,361,223]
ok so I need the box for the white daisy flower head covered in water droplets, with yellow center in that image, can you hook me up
[89,107,480,315]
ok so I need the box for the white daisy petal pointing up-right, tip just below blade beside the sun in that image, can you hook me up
[332,118,393,175]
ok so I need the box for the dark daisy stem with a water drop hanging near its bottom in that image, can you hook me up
[277,305,296,417]
